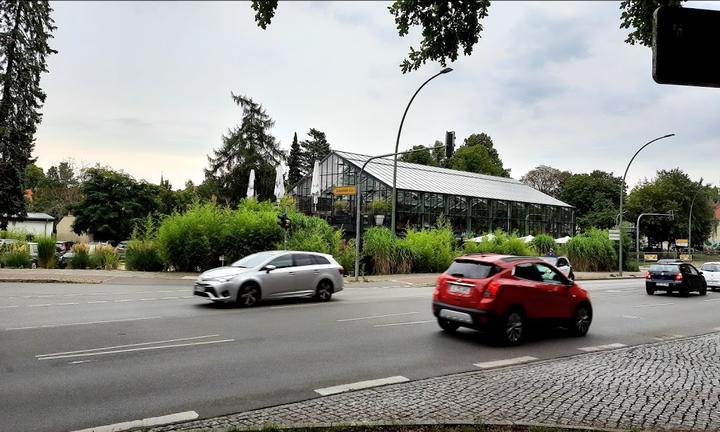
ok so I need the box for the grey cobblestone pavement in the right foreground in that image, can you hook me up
[151,333,720,432]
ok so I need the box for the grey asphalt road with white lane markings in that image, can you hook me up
[0,280,720,432]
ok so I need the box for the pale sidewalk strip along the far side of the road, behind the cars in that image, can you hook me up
[0,269,644,287]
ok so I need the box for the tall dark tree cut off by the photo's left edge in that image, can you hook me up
[0,0,56,229]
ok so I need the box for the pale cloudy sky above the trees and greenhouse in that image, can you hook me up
[34,1,720,188]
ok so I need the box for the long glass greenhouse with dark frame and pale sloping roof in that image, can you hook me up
[290,151,575,238]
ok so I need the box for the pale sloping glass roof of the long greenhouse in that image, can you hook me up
[333,150,572,207]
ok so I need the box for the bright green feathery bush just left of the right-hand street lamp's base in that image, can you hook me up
[567,228,617,271]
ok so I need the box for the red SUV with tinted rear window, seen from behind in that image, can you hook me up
[433,254,592,345]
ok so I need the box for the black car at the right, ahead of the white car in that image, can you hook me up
[645,263,707,295]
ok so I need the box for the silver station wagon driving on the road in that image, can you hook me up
[193,251,345,307]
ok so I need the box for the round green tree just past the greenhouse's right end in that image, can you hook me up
[558,170,624,230]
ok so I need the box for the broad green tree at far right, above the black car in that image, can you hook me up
[626,168,716,247]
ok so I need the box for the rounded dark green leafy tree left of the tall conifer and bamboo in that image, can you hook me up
[72,166,156,240]
